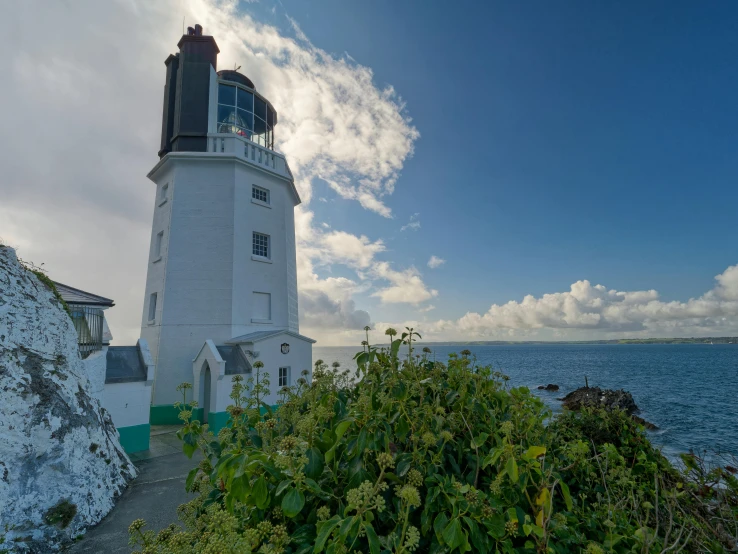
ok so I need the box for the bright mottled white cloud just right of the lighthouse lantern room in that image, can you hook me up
[196,7,419,217]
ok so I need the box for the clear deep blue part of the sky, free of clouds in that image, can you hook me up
[268,0,738,336]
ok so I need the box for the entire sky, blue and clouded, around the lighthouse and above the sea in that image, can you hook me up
[0,0,738,345]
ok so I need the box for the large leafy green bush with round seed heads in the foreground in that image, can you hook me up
[130,330,738,554]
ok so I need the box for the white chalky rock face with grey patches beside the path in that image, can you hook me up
[0,246,136,552]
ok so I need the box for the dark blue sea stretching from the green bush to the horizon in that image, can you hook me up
[313,343,738,459]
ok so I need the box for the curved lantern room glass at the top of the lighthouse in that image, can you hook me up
[217,83,275,150]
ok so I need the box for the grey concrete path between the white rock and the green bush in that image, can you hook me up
[67,427,202,554]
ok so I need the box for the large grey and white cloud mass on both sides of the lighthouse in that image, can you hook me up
[0,0,426,344]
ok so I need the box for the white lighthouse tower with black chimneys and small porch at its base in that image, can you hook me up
[141,25,315,430]
